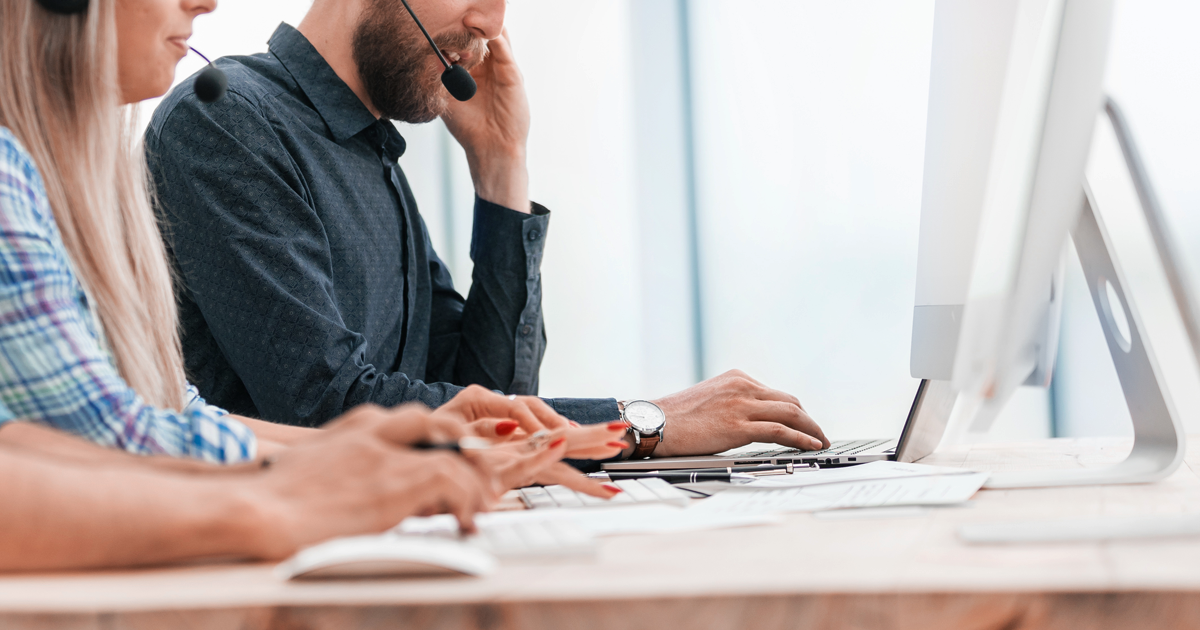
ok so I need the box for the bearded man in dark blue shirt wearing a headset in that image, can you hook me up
[146,0,828,456]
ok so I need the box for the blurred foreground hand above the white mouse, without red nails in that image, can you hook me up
[246,404,499,558]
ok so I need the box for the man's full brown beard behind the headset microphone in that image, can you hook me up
[353,0,487,124]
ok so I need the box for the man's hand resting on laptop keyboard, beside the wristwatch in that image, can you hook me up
[654,370,829,457]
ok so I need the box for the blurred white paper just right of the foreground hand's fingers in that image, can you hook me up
[392,504,779,536]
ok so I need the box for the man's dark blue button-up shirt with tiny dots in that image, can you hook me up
[145,24,618,426]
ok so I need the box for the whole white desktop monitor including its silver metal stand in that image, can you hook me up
[911,0,1185,487]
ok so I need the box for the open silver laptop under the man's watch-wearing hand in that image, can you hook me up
[604,379,958,470]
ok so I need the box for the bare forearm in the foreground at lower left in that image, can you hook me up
[0,446,265,571]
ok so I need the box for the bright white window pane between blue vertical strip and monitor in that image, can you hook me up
[692,0,934,437]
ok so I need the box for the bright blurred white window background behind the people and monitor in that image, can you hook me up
[142,0,1200,439]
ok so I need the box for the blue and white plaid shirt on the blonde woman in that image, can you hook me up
[0,127,257,462]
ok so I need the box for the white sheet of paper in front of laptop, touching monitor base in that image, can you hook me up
[688,473,988,514]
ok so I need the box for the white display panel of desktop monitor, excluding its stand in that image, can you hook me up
[910,0,1112,431]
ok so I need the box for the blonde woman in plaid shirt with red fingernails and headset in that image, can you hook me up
[0,0,624,477]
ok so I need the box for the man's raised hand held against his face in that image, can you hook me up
[442,30,532,212]
